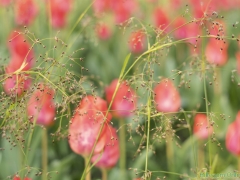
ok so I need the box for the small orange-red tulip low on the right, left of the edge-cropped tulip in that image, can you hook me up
[193,114,213,139]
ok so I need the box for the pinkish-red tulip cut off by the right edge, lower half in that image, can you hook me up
[226,111,240,156]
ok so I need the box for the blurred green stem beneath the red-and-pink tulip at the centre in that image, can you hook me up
[119,119,126,177]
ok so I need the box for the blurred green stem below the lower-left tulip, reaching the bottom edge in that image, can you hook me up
[42,128,48,180]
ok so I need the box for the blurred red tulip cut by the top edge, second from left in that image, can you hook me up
[48,0,72,28]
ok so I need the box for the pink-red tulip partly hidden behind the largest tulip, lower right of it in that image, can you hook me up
[91,125,120,168]
